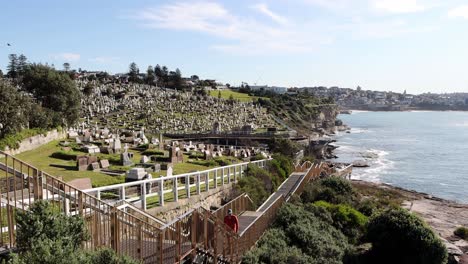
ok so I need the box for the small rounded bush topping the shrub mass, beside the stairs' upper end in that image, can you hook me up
[301,177,356,204]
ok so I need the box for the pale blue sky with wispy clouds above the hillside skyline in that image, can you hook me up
[0,0,468,93]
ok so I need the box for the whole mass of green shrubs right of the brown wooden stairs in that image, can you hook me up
[243,177,447,264]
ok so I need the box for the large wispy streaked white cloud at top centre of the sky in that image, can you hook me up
[135,2,330,54]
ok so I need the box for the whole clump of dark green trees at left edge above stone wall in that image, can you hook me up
[0,57,80,146]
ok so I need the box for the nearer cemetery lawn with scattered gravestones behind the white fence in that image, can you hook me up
[13,124,269,187]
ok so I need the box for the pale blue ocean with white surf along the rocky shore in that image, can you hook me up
[334,111,468,203]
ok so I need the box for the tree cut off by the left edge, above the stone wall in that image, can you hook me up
[0,80,31,138]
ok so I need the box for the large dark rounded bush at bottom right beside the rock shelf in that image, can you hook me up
[367,209,447,264]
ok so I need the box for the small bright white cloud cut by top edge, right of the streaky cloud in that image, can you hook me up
[370,0,429,14]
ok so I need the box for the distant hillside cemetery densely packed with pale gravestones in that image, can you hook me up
[77,81,284,136]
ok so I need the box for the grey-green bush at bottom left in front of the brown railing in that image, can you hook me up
[9,201,138,264]
